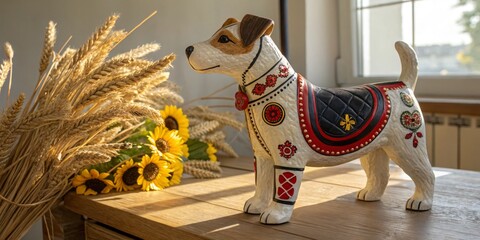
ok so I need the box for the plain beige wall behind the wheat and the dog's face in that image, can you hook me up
[0,0,279,106]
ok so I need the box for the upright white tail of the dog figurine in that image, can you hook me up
[395,41,418,91]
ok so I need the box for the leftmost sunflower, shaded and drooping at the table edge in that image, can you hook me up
[72,169,114,196]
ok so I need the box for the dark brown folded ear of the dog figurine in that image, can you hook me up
[240,14,273,46]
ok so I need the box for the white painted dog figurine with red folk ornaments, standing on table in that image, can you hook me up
[185,15,435,224]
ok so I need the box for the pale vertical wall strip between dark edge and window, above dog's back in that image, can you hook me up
[288,0,339,87]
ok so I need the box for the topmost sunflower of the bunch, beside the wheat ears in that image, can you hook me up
[160,105,190,141]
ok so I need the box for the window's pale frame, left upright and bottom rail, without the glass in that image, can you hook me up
[336,0,480,99]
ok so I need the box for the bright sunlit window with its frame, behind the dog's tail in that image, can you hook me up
[337,0,480,98]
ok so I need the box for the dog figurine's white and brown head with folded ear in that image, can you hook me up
[185,15,282,81]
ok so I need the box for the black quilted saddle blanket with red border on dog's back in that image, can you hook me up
[298,77,405,155]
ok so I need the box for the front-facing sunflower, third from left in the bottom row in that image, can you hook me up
[137,154,172,191]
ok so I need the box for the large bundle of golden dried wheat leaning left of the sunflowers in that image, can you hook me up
[0,15,178,239]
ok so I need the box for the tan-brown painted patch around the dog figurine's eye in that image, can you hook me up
[210,29,253,55]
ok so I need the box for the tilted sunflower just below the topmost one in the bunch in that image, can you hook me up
[147,126,184,161]
